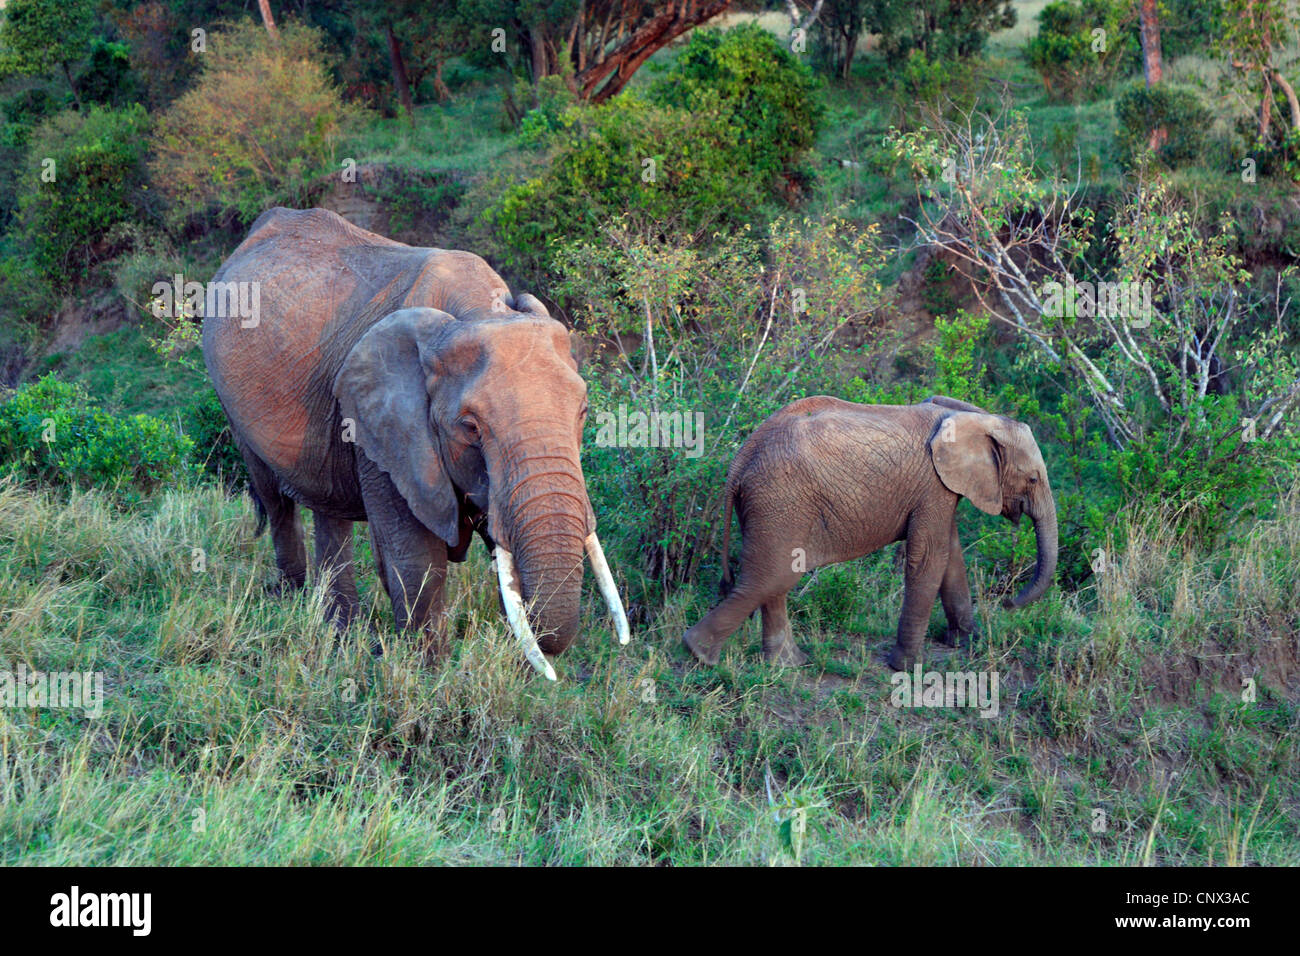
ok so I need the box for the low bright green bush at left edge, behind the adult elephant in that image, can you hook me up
[0,376,194,494]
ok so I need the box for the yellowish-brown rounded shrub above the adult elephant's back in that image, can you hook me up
[153,21,350,220]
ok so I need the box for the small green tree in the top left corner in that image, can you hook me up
[0,0,95,109]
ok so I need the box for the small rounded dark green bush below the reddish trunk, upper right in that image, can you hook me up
[1115,82,1212,168]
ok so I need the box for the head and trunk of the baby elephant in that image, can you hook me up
[930,406,1057,607]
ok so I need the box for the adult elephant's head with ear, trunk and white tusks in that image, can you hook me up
[334,303,628,678]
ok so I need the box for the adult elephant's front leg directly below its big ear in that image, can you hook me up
[358,457,447,663]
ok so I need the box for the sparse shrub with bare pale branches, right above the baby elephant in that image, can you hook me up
[888,104,1300,467]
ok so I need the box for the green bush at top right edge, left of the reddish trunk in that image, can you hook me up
[1024,0,1141,101]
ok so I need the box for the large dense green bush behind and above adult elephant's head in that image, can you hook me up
[478,30,820,280]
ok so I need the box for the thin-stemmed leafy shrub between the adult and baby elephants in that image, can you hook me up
[556,219,884,594]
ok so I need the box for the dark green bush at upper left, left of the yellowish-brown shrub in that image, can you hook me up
[10,104,150,280]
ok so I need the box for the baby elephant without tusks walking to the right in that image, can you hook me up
[683,395,1057,670]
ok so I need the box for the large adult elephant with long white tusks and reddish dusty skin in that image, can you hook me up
[203,208,628,679]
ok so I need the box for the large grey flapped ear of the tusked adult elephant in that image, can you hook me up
[334,308,460,545]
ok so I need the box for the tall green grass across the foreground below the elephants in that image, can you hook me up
[0,484,1300,865]
